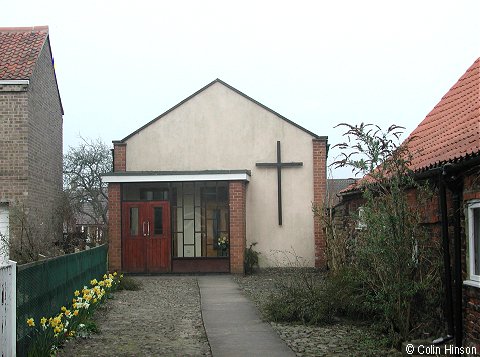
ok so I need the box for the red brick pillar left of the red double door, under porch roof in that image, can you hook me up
[108,183,122,271]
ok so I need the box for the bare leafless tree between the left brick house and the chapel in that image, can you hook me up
[63,138,112,236]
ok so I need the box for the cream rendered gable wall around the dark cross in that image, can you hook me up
[126,82,314,266]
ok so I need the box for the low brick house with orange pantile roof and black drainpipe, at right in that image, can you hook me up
[335,58,480,351]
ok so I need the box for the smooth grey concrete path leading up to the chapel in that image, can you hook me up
[198,275,295,357]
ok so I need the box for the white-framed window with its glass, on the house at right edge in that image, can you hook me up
[467,200,480,287]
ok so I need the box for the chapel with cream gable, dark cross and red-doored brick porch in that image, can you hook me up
[103,79,327,273]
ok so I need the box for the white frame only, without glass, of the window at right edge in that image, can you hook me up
[464,200,480,288]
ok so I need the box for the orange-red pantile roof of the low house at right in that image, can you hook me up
[407,58,480,172]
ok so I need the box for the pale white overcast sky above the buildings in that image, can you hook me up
[0,0,480,177]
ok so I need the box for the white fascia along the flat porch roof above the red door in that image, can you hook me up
[102,172,250,183]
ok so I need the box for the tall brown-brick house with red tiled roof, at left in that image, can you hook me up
[0,26,63,258]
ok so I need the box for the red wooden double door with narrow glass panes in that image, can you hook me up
[122,201,171,273]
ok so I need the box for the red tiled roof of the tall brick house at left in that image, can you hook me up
[0,26,48,80]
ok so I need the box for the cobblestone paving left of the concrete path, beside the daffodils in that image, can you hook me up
[58,276,211,357]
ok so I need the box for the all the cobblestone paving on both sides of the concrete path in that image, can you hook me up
[58,269,401,357]
